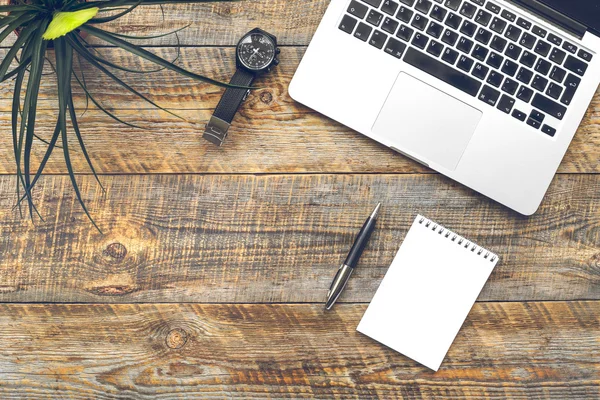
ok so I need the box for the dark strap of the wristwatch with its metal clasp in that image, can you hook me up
[203,68,256,146]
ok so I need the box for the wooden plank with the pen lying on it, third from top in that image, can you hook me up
[0,175,600,303]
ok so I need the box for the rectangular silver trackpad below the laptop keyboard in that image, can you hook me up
[373,72,482,170]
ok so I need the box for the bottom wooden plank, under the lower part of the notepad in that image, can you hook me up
[0,301,600,400]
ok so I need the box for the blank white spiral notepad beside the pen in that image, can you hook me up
[357,215,498,371]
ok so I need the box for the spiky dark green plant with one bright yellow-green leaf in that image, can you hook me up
[0,0,239,228]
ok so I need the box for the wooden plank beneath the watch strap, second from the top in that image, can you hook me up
[0,48,600,174]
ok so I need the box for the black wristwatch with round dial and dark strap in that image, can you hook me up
[203,28,280,146]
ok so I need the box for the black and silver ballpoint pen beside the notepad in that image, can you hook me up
[325,203,381,310]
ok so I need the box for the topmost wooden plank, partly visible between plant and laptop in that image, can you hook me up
[2,0,329,46]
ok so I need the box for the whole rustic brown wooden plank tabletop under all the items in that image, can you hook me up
[0,0,600,400]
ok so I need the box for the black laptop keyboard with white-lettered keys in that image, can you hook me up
[339,0,592,136]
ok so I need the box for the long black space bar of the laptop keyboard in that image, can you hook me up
[403,47,481,96]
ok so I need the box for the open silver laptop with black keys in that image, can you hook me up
[289,0,600,215]
